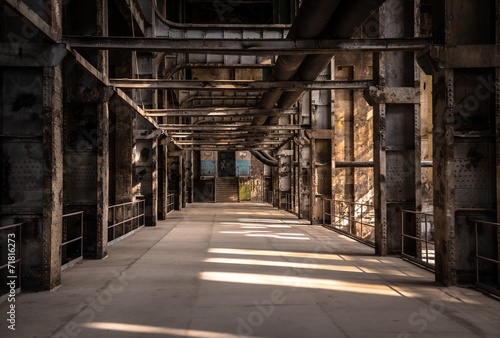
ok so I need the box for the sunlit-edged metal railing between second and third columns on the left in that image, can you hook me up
[108,200,146,245]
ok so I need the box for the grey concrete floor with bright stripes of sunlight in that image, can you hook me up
[0,203,500,338]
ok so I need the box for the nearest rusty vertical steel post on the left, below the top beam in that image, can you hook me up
[41,66,63,290]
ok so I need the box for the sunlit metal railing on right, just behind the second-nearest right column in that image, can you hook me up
[321,197,375,246]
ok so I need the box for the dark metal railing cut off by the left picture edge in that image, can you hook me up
[0,223,23,303]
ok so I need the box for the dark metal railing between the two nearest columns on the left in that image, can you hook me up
[61,211,83,270]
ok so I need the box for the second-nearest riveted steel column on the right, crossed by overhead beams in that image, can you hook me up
[374,0,421,255]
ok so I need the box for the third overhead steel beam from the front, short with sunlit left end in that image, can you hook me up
[146,107,297,117]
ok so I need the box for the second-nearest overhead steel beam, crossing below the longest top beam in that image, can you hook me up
[110,79,374,91]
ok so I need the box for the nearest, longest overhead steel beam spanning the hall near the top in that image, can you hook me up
[63,36,432,55]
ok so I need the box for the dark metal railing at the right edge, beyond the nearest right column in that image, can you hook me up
[471,220,500,296]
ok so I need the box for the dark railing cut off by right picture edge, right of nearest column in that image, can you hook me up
[471,220,500,296]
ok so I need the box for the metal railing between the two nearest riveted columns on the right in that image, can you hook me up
[400,209,435,270]
